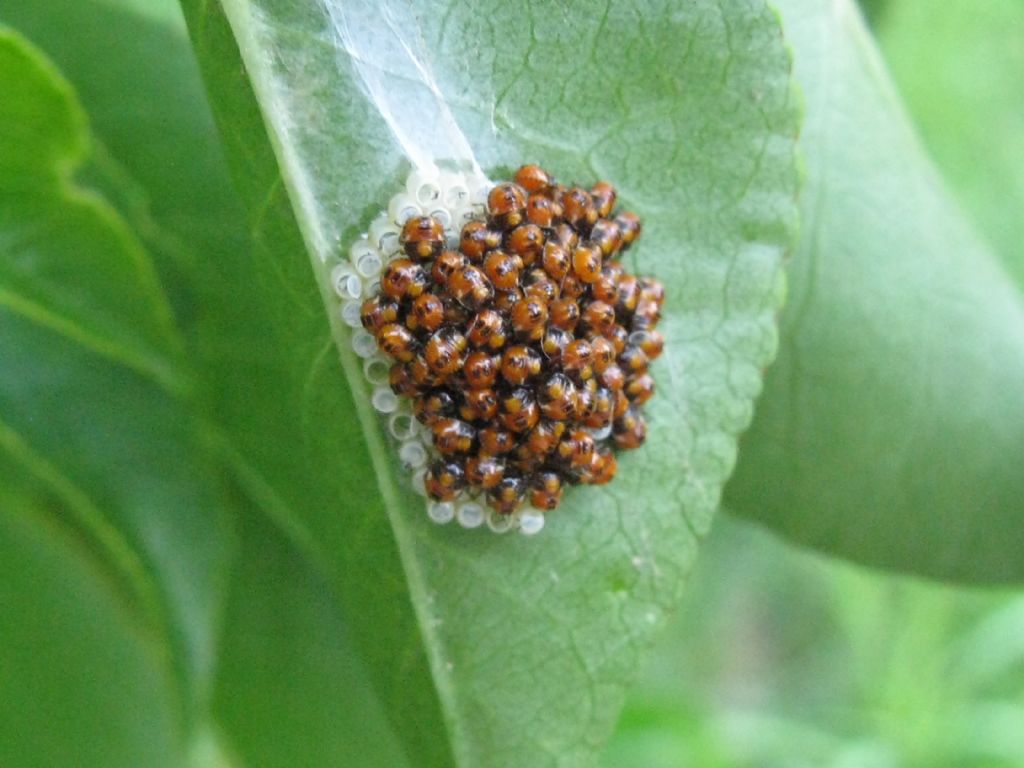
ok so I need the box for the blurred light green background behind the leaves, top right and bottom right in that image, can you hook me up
[604,0,1024,768]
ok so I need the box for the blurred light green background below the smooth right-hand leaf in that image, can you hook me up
[604,517,1024,768]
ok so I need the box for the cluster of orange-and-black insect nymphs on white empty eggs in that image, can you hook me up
[331,165,665,535]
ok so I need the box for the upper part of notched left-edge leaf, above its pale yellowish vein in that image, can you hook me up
[0,36,181,387]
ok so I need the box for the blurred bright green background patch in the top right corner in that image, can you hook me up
[879,0,1024,286]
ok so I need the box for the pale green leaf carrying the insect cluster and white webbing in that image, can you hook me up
[176,3,794,765]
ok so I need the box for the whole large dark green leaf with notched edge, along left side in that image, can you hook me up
[0,28,230,765]
